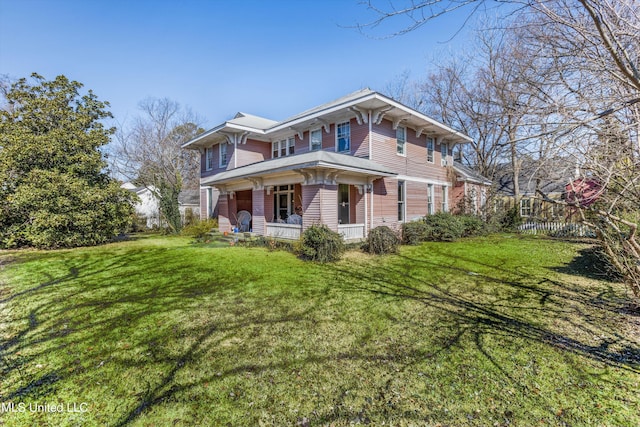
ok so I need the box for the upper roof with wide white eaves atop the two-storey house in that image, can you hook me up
[182,88,472,149]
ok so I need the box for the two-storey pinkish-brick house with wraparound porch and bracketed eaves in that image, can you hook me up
[183,89,478,240]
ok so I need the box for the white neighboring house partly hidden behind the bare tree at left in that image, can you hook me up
[121,182,200,228]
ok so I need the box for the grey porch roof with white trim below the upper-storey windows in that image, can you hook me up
[200,151,397,185]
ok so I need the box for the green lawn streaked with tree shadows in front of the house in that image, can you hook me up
[0,236,640,426]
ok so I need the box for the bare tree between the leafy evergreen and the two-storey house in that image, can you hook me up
[114,98,204,232]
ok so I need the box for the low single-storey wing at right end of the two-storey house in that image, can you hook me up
[451,161,492,215]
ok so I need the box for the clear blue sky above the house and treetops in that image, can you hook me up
[0,0,476,127]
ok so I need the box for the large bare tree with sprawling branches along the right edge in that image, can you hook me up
[358,0,640,298]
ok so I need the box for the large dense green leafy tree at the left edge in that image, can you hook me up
[0,73,133,248]
